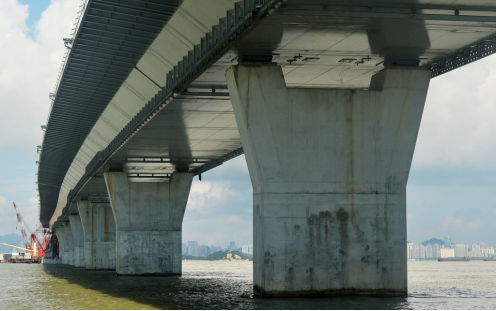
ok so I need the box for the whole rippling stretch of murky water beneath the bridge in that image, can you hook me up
[0,261,496,310]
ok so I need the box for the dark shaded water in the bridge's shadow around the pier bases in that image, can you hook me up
[43,266,414,310]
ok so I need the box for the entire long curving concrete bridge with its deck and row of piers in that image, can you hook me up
[38,0,496,297]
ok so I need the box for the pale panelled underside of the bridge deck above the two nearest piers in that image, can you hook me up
[42,0,496,225]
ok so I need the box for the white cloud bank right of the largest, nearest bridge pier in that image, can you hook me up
[413,56,496,169]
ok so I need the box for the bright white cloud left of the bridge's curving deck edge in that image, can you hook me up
[0,0,80,154]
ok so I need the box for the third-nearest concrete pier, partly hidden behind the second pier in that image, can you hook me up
[78,201,117,270]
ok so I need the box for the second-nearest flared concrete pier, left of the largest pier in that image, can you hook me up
[104,172,193,275]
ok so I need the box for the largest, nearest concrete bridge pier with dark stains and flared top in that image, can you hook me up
[226,66,430,297]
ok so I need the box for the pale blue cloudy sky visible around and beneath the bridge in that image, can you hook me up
[0,0,496,246]
